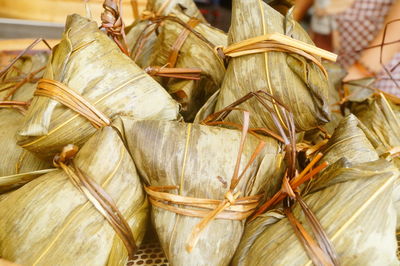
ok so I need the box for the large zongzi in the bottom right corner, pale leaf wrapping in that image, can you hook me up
[232,158,399,265]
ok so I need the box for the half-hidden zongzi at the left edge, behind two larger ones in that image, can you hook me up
[0,52,50,193]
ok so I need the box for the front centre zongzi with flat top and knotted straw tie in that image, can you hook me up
[115,118,284,265]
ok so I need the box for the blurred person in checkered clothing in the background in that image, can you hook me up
[294,0,400,96]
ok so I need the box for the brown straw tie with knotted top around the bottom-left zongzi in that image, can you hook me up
[53,144,137,265]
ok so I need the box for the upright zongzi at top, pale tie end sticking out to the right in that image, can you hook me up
[216,0,335,131]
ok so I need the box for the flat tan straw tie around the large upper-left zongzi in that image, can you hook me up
[34,79,110,128]
